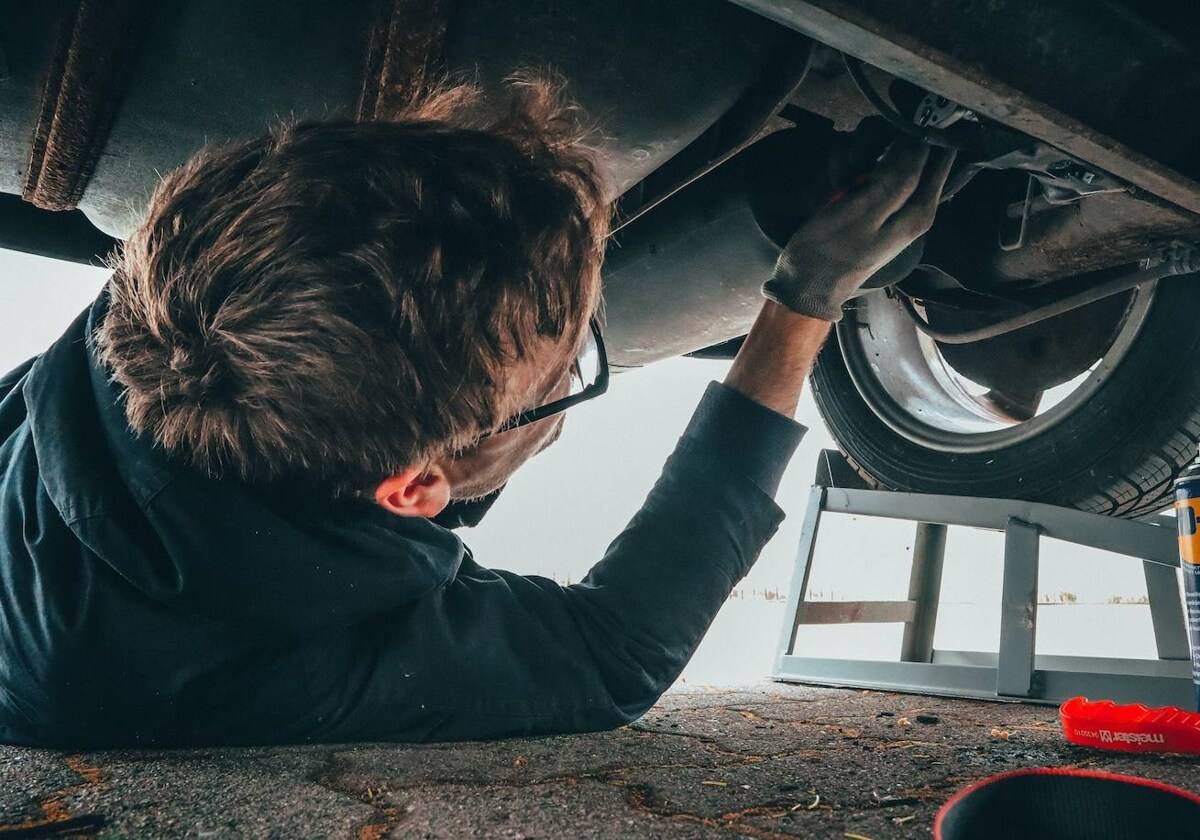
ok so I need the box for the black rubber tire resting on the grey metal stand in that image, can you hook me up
[811,276,1200,517]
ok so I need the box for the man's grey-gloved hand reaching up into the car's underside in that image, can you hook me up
[762,138,954,322]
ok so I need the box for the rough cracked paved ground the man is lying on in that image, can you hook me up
[0,684,1200,840]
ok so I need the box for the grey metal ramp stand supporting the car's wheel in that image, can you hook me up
[774,450,1194,708]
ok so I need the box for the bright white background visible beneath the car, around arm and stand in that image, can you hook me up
[0,251,1153,683]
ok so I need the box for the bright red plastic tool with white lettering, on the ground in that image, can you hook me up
[1058,697,1200,755]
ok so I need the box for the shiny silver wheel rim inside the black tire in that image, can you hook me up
[836,286,1154,452]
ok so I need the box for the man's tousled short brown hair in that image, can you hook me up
[97,79,608,492]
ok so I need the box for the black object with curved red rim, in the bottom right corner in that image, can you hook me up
[934,767,1200,840]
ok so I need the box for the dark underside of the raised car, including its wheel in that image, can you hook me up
[0,0,1200,516]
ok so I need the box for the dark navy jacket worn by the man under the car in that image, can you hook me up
[0,295,803,748]
